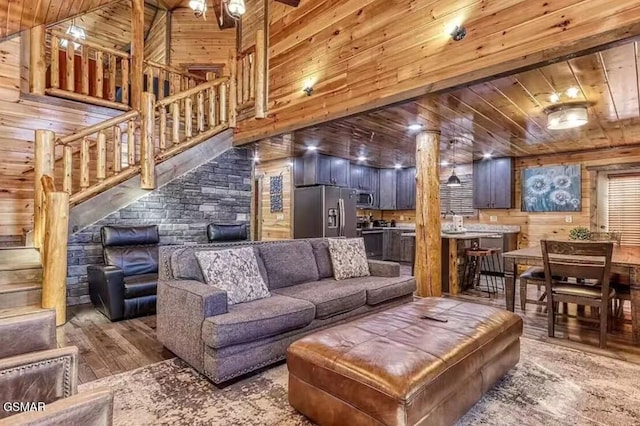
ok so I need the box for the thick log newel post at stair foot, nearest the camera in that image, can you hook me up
[42,184,69,325]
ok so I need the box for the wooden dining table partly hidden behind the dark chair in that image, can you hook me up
[502,246,640,344]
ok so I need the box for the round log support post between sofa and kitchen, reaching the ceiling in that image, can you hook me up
[414,100,448,297]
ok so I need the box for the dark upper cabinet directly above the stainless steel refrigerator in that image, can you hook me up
[294,154,349,187]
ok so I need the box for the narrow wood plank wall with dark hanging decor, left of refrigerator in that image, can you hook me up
[255,159,293,241]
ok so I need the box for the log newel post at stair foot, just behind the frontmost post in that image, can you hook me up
[33,130,56,249]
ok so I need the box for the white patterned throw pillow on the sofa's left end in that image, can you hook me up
[196,247,271,305]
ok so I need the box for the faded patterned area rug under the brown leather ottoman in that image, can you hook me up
[80,338,640,426]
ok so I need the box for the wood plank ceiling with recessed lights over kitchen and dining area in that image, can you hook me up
[259,41,640,167]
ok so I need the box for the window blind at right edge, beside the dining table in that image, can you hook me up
[607,174,640,245]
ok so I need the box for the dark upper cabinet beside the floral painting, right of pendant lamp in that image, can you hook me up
[473,157,514,209]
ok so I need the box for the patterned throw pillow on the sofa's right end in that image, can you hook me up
[329,238,371,280]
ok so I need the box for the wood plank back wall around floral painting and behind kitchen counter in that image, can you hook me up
[382,147,640,248]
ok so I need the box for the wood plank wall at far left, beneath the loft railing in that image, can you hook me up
[0,37,121,241]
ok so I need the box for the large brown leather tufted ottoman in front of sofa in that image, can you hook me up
[287,298,522,426]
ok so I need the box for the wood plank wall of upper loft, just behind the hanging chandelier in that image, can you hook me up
[171,9,236,66]
